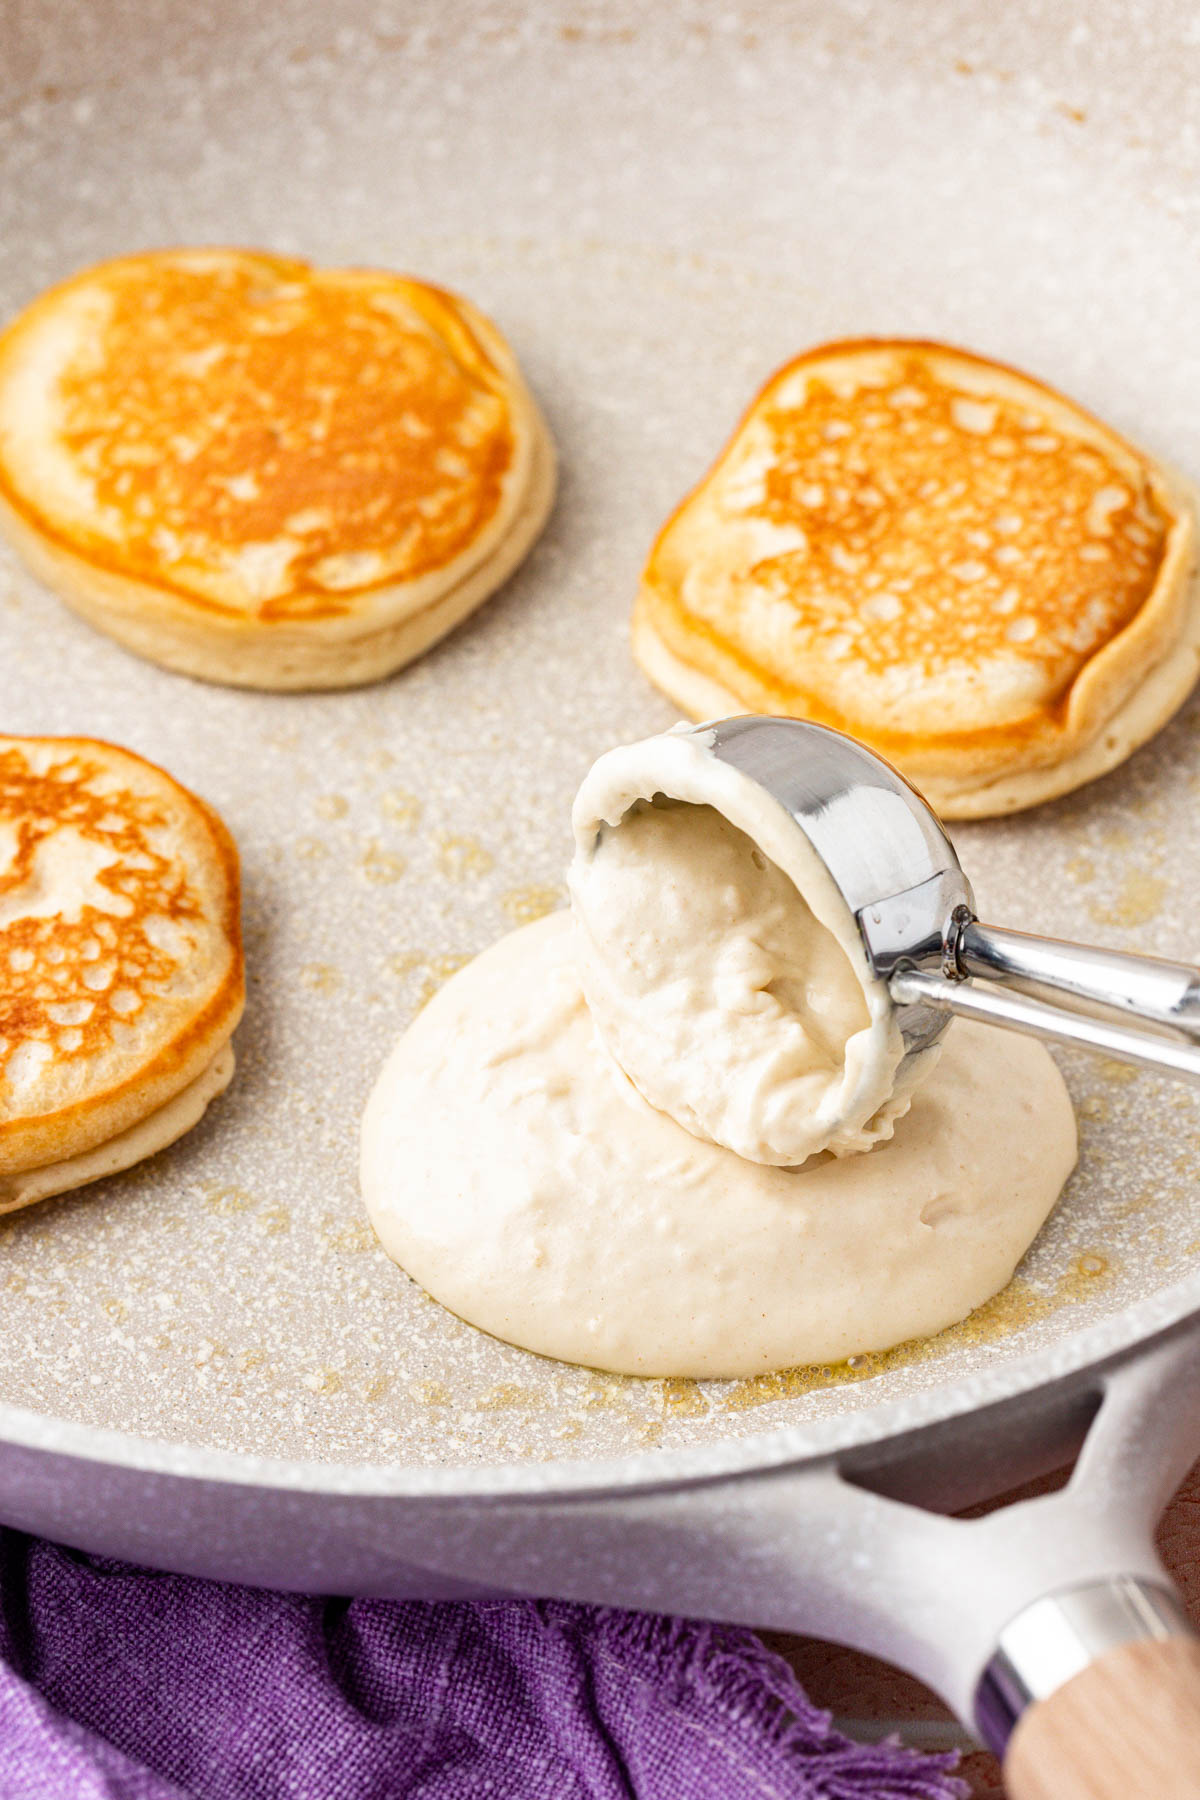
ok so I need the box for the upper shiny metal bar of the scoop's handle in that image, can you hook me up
[954,918,1200,1042]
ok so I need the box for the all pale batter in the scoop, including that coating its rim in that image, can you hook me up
[570,733,936,1166]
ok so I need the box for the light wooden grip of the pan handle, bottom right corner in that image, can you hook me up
[1004,1638,1200,1800]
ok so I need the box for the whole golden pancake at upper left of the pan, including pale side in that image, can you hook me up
[0,250,554,688]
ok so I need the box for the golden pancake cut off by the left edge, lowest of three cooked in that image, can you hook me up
[0,738,245,1211]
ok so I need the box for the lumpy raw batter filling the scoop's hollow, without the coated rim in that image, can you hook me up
[572,801,891,1165]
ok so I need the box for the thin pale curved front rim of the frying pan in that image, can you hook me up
[0,1269,1200,1505]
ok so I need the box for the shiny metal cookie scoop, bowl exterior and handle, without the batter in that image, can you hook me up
[694,716,1200,1080]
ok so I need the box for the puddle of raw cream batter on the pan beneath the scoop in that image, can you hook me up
[362,913,1076,1377]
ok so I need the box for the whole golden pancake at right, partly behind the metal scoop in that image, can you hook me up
[633,340,1200,817]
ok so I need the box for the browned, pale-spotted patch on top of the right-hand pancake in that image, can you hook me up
[750,356,1169,697]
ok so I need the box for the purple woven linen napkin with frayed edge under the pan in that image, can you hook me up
[0,1530,966,1800]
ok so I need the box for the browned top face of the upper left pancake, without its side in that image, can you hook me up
[2,252,515,623]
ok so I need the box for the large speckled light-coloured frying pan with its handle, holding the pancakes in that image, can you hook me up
[0,0,1200,1800]
